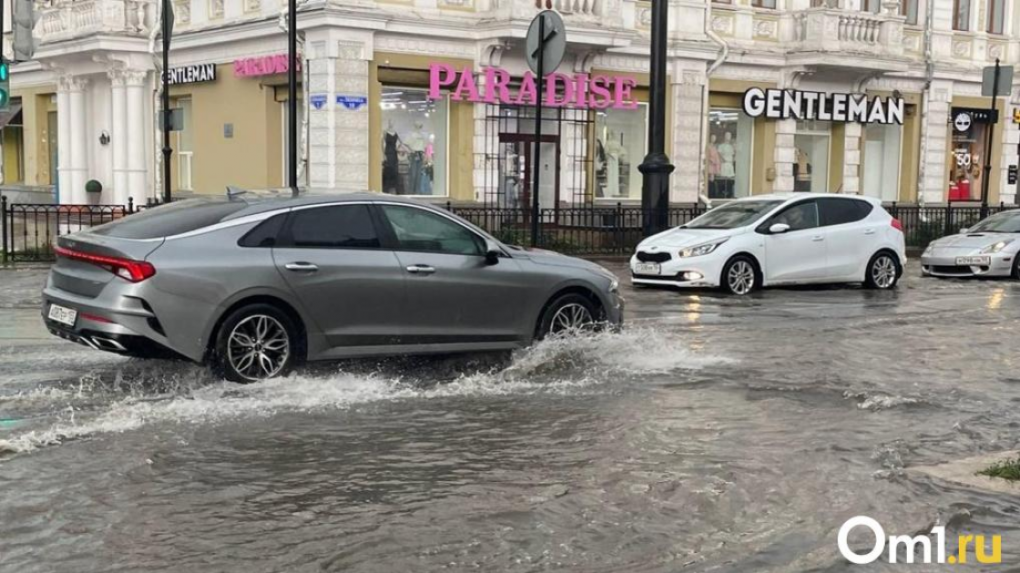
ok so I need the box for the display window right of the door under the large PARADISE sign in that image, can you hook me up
[595,104,648,200]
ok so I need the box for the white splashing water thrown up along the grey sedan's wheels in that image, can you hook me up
[0,329,728,453]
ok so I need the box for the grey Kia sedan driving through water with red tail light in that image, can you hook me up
[42,194,623,382]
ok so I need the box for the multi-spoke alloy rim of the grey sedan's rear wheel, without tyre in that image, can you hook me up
[226,314,291,380]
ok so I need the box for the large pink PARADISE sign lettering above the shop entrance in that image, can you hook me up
[428,63,638,109]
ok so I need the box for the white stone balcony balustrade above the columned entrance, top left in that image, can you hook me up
[36,0,156,44]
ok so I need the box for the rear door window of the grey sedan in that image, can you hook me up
[279,205,381,249]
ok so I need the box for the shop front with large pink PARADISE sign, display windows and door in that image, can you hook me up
[370,55,647,208]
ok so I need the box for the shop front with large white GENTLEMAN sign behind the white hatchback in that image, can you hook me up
[705,81,919,201]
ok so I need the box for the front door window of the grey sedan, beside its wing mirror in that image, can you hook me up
[381,205,486,255]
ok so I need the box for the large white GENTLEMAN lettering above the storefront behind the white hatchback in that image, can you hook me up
[744,88,905,124]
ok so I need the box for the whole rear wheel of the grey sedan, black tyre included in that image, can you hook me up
[212,303,300,383]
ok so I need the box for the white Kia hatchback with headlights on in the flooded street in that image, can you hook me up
[630,193,907,295]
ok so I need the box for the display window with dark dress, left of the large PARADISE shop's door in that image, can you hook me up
[379,86,449,196]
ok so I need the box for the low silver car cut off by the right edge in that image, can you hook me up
[921,210,1020,278]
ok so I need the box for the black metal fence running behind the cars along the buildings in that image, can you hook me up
[0,197,1017,263]
